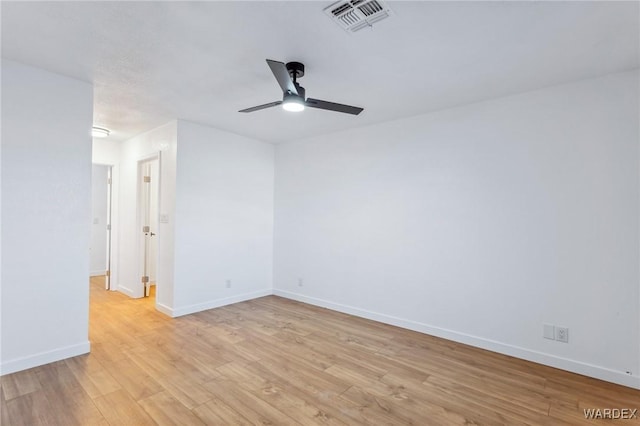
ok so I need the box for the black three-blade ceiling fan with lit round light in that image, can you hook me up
[238,59,363,115]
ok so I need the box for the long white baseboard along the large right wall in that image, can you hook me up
[273,289,640,389]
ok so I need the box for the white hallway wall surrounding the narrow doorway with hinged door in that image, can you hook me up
[117,121,177,314]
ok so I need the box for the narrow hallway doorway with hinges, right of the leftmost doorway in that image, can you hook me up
[138,156,160,299]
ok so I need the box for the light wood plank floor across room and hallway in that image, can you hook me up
[0,279,640,426]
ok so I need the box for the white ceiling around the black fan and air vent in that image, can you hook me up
[1,1,640,143]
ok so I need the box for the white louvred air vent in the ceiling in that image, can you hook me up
[324,0,391,32]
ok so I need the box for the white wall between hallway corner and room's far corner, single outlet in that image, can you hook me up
[172,121,274,316]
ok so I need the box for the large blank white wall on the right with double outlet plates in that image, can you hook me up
[274,72,640,387]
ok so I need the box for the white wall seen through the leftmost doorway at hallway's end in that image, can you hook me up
[89,164,109,276]
